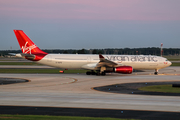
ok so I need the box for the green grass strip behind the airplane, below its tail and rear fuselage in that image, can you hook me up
[0,68,87,74]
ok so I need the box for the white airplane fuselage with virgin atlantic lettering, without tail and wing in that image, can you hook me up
[38,54,171,70]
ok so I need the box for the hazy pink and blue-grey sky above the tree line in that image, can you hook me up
[0,0,180,50]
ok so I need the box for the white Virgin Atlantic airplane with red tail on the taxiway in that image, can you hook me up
[14,30,172,75]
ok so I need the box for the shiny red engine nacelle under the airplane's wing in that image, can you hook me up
[114,66,133,74]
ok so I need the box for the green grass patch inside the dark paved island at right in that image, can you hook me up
[138,85,180,93]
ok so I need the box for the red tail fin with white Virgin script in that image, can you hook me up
[14,30,47,54]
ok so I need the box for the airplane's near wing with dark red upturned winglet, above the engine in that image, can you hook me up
[96,54,123,68]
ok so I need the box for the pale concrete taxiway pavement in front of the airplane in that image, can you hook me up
[0,67,180,112]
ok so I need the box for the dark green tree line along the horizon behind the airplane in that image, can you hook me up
[0,47,180,56]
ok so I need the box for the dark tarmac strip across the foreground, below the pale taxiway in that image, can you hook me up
[0,106,180,120]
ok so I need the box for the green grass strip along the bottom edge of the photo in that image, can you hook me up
[0,115,136,120]
